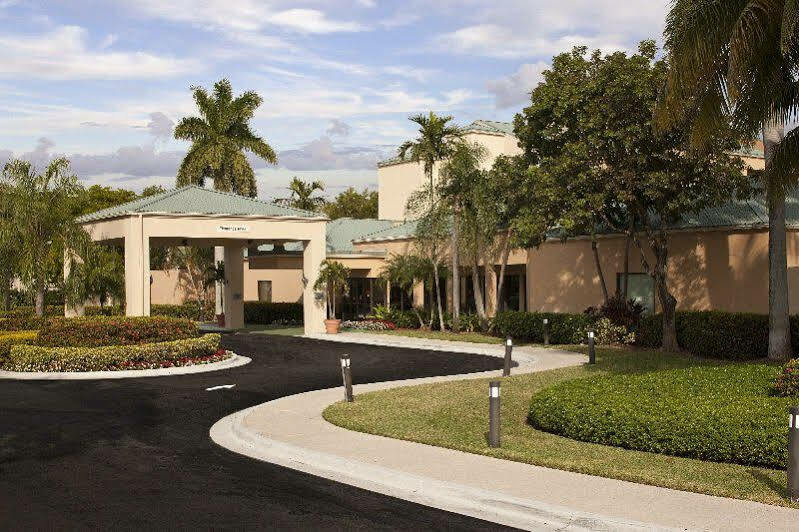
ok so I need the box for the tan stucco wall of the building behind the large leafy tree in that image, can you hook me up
[527,230,799,313]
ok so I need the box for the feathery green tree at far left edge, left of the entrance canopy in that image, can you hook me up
[2,158,89,316]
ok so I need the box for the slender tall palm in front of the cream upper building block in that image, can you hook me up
[398,111,463,331]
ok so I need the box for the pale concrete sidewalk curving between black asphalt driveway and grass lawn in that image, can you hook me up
[211,335,799,530]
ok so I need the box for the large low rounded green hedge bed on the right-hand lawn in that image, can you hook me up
[528,364,790,469]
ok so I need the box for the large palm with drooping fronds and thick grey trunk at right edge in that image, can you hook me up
[658,0,799,360]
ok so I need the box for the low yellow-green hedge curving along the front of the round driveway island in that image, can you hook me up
[3,334,227,371]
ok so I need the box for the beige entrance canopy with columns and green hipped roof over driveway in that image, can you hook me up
[72,186,327,334]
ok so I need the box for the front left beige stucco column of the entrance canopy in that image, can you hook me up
[125,216,150,316]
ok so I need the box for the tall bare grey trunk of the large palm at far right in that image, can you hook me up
[763,124,791,360]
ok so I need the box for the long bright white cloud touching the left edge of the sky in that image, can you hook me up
[0,26,199,79]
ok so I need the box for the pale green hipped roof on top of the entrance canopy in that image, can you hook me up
[78,185,324,223]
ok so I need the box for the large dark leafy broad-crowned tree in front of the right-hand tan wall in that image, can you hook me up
[515,41,749,350]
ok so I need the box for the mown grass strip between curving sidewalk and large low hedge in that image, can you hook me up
[324,348,799,508]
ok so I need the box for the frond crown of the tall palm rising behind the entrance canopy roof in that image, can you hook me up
[175,79,277,198]
